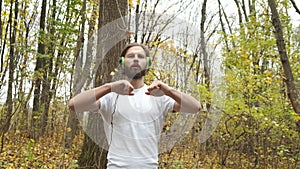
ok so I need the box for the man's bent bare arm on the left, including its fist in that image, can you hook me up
[68,80,133,112]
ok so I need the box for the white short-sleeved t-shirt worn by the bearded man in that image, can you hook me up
[100,85,175,169]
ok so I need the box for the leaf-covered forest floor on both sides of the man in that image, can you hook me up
[0,130,300,169]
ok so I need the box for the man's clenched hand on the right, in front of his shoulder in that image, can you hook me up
[145,80,171,96]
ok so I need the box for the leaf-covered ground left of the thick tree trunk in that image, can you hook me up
[0,130,83,169]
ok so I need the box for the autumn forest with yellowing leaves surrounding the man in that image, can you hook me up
[0,0,300,169]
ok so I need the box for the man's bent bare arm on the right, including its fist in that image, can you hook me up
[146,81,201,113]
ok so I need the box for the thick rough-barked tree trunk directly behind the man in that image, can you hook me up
[78,0,127,169]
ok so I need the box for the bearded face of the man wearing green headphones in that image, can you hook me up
[125,46,147,79]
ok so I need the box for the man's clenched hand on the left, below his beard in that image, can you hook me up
[110,80,134,95]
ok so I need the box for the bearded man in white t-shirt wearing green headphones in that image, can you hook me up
[69,43,200,169]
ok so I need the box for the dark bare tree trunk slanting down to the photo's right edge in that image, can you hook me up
[268,0,300,129]
